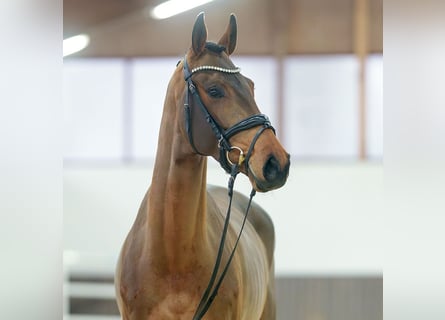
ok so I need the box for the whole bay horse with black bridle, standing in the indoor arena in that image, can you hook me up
[115,13,290,320]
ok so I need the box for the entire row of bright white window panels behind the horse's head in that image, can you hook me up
[63,55,383,163]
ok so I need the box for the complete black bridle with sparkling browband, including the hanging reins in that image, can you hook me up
[183,57,275,320]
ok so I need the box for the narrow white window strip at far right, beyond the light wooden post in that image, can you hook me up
[366,55,383,159]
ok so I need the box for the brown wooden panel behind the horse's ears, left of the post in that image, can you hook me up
[68,0,271,57]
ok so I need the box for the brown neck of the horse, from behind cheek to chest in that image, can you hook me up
[147,77,207,269]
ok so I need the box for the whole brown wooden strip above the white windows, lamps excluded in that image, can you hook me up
[63,0,383,57]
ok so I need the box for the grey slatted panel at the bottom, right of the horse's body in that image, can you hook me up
[276,276,383,320]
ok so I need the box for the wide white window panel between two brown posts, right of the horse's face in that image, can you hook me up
[284,55,358,158]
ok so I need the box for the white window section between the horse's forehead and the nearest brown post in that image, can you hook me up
[232,57,279,124]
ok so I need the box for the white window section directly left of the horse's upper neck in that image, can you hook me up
[132,58,178,160]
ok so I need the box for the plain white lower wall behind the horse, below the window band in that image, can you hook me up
[64,160,382,275]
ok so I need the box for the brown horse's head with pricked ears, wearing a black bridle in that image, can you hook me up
[178,13,290,192]
